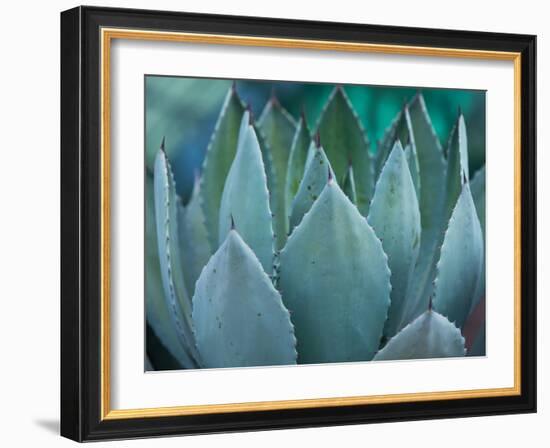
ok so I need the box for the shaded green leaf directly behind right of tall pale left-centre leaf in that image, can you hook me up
[258,97,296,249]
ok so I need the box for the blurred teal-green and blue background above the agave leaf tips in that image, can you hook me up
[145,75,485,202]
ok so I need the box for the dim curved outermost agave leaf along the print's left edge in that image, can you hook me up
[145,173,195,368]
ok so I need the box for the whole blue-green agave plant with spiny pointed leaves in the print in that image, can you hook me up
[146,83,485,368]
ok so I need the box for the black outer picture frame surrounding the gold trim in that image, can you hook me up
[61,7,537,441]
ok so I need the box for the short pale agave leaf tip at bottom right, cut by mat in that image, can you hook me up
[374,310,465,361]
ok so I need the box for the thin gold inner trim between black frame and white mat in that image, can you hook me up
[100,28,521,420]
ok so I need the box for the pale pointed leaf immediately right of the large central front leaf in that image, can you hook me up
[368,140,421,338]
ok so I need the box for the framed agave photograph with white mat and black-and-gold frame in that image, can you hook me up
[61,7,536,441]
